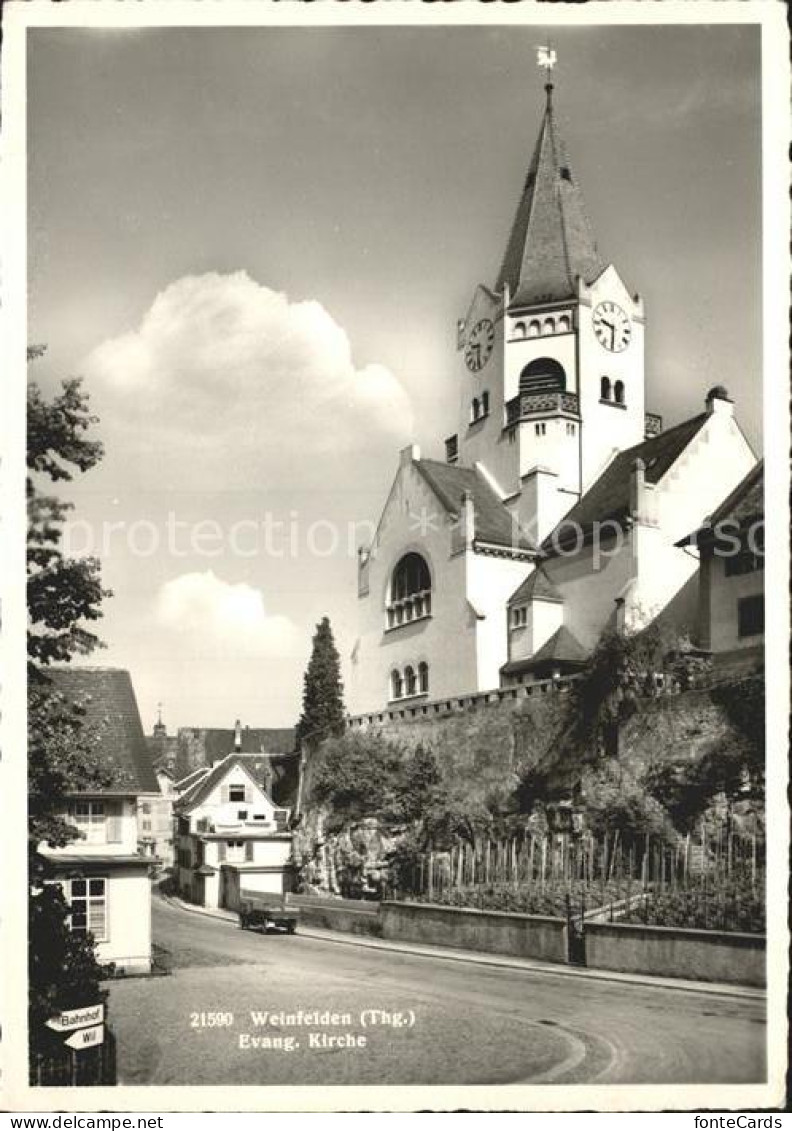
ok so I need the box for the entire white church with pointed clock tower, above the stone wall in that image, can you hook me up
[348,83,756,715]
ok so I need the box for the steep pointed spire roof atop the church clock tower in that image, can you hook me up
[496,83,606,305]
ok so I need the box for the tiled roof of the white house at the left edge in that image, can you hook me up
[44,667,160,793]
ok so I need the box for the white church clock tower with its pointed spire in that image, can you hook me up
[446,70,645,543]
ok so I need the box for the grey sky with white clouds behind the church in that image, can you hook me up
[28,25,761,731]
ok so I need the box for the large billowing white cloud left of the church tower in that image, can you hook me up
[84,271,412,485]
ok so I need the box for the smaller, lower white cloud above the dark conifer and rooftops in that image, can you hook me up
[155,570,303,656]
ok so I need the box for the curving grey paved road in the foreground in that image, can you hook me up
[110,898,765,1086]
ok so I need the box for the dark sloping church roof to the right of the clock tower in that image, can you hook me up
[542,413,707,556]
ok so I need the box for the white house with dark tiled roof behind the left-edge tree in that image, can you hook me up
[40,667,160,973]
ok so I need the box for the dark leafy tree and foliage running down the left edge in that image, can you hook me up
[26,346,110,1053]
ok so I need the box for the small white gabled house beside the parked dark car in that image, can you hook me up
[175,726,293,910]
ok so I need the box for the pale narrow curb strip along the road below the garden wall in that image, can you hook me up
[157,892,766,1001]
